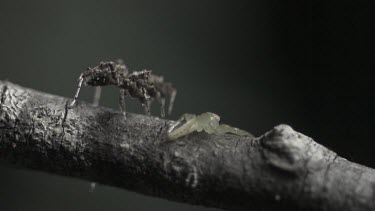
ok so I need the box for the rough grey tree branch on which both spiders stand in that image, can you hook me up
[0,81,375,211]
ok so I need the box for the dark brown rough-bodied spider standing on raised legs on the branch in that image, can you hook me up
[70,60,177,117]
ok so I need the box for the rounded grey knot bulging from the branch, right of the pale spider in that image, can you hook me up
[260,125,310,174]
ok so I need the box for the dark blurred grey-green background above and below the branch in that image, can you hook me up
[0,0,375,211]
